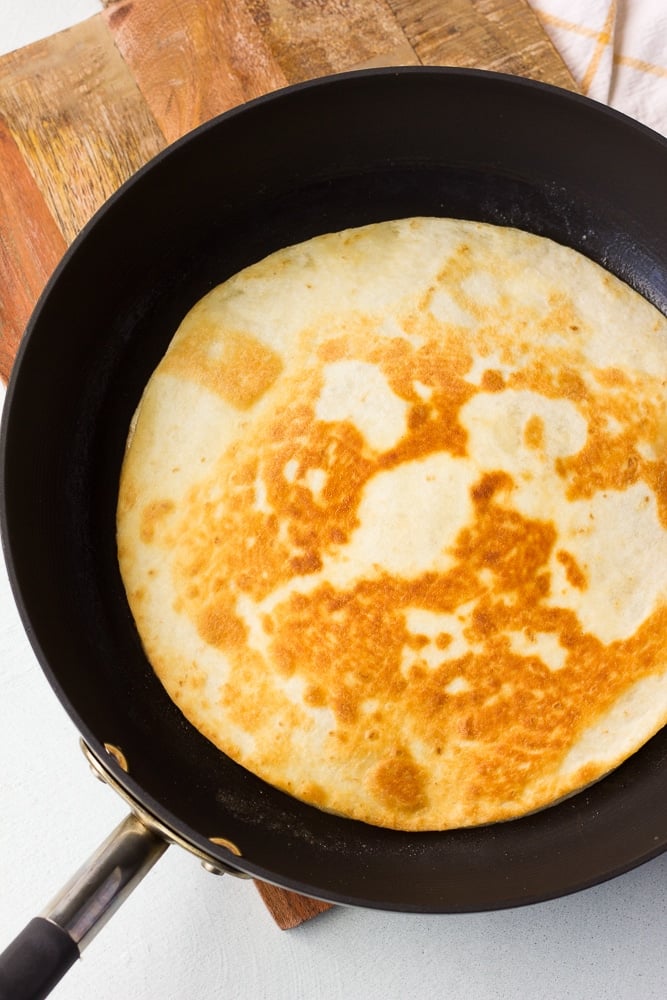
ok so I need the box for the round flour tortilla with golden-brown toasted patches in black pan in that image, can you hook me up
[118,218,667,830]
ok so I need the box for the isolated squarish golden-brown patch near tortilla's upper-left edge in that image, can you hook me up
[162,322,283,410]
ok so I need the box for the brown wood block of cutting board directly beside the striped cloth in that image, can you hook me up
[387,0,577,90]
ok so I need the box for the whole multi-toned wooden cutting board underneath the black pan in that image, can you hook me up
[0,0,576,928]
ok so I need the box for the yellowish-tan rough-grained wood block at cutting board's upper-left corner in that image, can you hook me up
[0,14,165,243]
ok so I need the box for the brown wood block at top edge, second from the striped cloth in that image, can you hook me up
[245,0,418,83]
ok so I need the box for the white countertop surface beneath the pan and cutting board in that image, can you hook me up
[0,0,667,1000]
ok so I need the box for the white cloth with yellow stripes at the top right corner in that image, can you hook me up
[529,0,667,135]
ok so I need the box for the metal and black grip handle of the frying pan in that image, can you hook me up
[0,814,168,1000]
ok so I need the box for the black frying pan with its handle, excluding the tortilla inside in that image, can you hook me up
[0,67,667,1000]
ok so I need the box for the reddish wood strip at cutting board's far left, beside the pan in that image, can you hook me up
[0,117,66,381]
